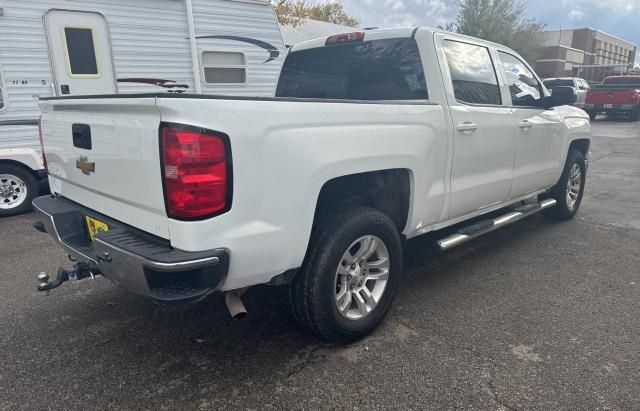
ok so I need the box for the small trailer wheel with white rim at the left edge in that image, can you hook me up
[0,164,38,216]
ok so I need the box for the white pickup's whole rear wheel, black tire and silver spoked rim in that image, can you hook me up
[290,207,402,343]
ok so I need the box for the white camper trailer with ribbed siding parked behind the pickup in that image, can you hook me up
[0,0,285,216]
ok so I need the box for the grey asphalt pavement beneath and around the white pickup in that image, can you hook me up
[0,120,640,410]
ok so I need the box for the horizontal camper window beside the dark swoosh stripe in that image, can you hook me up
[200,51,247,84]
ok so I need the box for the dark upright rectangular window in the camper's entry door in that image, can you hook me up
[64,27,100,76]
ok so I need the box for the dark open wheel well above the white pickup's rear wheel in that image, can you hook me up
[313,169,411,232]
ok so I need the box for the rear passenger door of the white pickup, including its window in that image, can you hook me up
[436,35,516,219]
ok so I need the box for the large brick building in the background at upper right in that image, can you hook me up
[536,28,636,82]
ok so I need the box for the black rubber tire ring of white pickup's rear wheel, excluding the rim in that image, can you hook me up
[289,207,402,343]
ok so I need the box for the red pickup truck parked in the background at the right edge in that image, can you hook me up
[584,76,640,121]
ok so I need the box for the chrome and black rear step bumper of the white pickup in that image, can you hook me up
[33,196,229,304]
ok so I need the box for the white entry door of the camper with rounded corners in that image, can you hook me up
[45,10,116,96]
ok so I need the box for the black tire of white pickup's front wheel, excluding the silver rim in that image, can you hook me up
[544,149,587,220]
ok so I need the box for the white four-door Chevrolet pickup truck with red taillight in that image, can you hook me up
[34,28,591,342]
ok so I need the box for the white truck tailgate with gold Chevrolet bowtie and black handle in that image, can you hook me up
[40,97,169,238]
